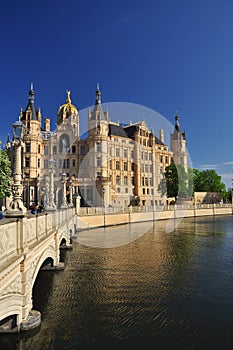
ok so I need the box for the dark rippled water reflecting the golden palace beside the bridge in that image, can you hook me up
[0,216,233,350]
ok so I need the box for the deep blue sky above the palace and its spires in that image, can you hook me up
[0,0,233,187]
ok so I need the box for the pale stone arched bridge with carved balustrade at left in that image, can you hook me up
[0,208,77,332]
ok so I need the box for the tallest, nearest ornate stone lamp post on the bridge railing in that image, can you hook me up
[5,120,27,217]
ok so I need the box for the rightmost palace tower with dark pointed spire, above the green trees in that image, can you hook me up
[170,112,188,172]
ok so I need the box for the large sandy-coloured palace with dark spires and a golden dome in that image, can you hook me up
[6,86,188,208]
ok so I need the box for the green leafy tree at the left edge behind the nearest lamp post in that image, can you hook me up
[0,151,11,199]
